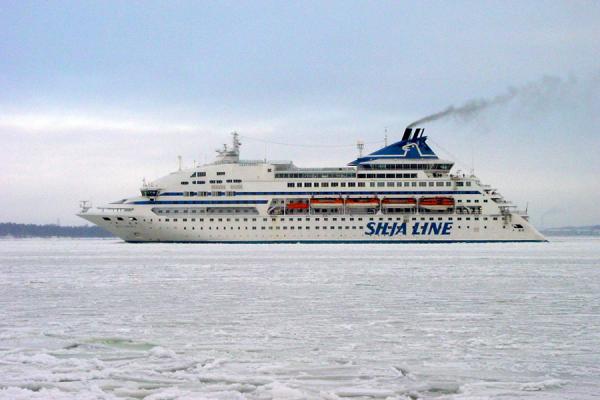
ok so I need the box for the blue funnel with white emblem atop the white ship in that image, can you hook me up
[348,128,438,166]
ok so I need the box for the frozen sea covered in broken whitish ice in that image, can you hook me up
[0,238,600,400]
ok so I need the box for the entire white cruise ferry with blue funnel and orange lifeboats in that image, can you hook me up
[78,128,545,243]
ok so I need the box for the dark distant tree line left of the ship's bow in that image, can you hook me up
[0,222,114,238]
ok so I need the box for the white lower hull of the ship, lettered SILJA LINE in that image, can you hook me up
[79,208,545,243]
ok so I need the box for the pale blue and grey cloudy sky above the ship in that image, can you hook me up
[0,1,600,226]
